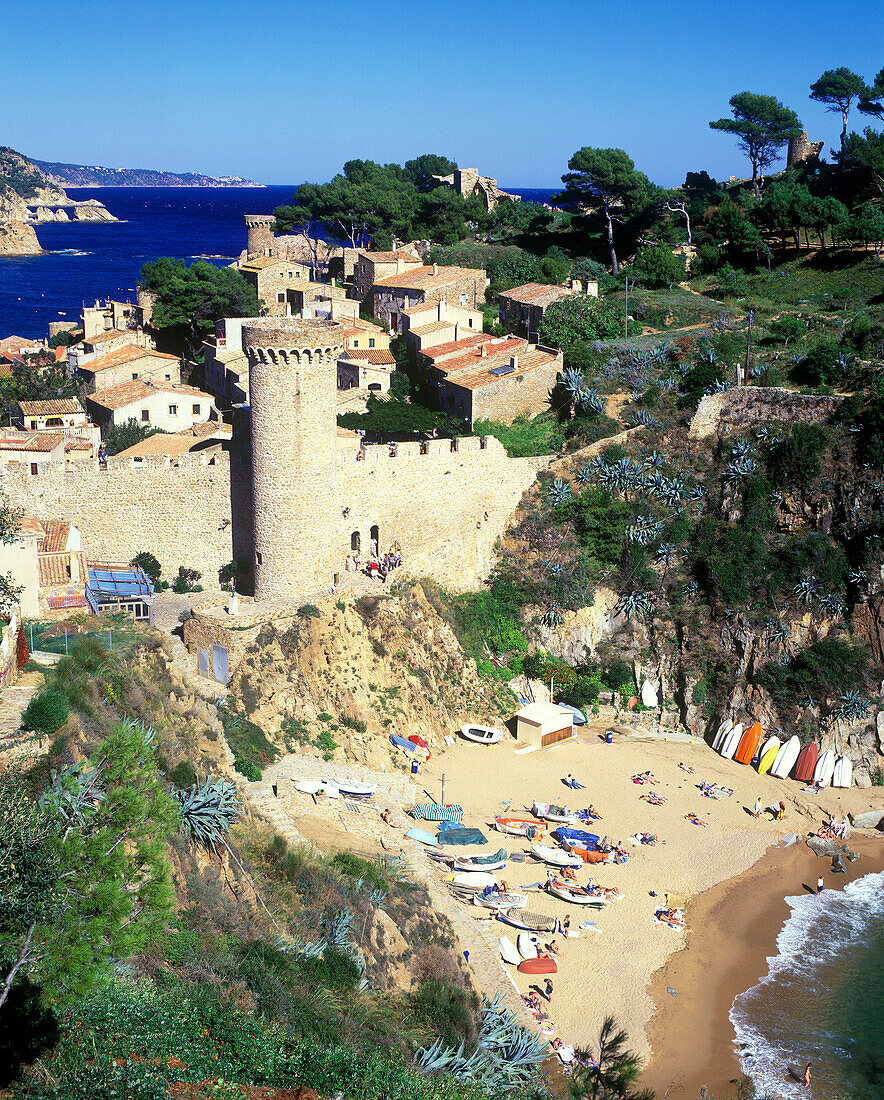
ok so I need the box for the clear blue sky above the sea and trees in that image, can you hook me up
[6,0,884,187]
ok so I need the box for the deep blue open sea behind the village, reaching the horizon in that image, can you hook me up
[0,184,553,339]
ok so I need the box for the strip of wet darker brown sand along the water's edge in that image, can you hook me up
[641,834,884,1098]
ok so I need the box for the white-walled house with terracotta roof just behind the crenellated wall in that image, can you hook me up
[86,378,218,432]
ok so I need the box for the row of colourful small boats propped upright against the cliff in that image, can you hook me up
[712,721,853,787]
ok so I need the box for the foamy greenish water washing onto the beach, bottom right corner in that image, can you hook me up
[730,872,884,1100]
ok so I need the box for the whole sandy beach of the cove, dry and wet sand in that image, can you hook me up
[271,729,884,1097]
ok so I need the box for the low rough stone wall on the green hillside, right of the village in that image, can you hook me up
[689,386,837,439]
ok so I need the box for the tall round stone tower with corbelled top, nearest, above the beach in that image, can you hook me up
[243,318,344,601]
